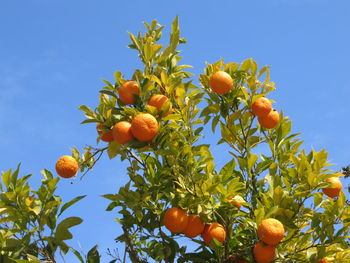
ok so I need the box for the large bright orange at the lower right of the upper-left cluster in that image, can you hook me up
[131,113,158,142]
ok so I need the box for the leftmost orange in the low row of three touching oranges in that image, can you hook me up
[163,207,188,233]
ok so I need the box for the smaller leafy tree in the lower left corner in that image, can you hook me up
[0,166,99,263]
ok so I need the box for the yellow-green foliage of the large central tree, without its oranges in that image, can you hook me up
[75,18,350,262]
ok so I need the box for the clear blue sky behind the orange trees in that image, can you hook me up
[0,0,350,263]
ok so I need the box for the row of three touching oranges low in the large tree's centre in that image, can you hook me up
[163,207,226,245]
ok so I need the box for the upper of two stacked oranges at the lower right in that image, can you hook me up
[258,218,285,245]
